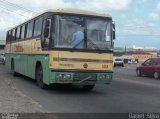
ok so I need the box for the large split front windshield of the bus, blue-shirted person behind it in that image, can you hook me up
[55,15,112,50]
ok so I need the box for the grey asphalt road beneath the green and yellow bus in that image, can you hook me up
[0,65,160,113]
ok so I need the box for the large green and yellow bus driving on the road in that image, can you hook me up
[5,9,115,90]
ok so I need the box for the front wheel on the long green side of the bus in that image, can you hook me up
[36,64,47,89]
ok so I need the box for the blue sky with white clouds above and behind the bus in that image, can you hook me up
[0,0,160,49]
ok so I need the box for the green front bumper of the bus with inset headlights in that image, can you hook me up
[51,72,113,85]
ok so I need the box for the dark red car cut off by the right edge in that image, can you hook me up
[136,58,160,79]
